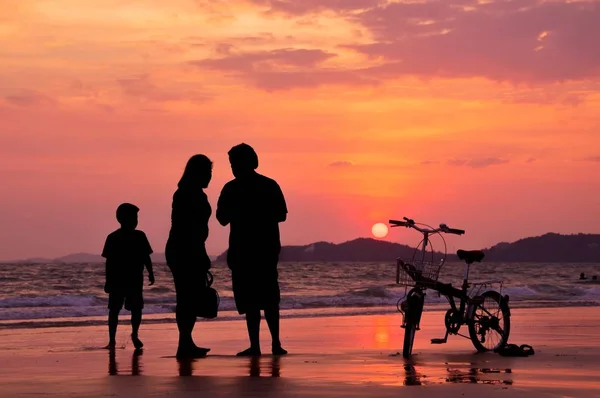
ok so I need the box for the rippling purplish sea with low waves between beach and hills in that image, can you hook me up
[0,262,600,328]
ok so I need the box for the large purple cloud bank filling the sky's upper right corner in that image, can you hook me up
[351,0,600,83]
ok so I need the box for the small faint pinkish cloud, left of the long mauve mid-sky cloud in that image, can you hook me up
[117,75,211,102]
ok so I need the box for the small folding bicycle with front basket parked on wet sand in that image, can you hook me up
[389,217,510,358]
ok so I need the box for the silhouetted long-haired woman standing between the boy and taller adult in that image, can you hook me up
[165,155,212,358]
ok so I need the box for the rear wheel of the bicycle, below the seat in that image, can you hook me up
[469,290,510,352]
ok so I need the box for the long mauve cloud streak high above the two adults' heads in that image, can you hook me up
[191,49,378,91]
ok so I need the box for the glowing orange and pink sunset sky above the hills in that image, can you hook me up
[0,0,600,260]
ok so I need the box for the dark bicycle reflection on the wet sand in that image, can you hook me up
[404,364,513,386]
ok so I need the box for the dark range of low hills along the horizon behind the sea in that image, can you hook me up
[10,233,600,264]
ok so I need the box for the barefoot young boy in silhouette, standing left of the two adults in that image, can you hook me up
[102,203,154,349]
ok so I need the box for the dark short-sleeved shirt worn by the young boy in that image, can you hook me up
[102,229,153,289]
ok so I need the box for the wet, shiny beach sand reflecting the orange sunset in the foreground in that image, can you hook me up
[0,307,600,398]
